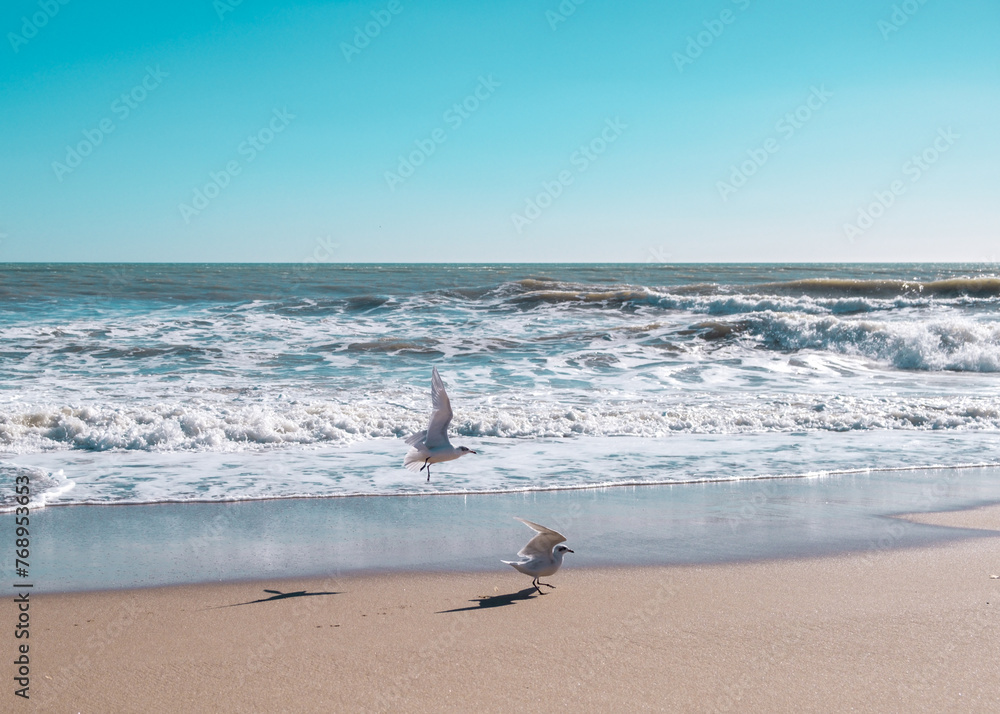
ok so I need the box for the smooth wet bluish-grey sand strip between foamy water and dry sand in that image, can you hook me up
[25,468,1000,592]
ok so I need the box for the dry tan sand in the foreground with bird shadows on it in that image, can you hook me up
[15,507,1000,712]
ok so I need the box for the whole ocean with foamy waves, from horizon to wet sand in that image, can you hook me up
[0,264,1000,512]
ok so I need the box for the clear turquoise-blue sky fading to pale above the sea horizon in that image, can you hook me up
[0,0,1000,262]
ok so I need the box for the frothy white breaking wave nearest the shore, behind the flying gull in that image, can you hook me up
[0,386,1000,453]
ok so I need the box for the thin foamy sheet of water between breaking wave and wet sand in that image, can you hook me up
[0,431,1000,510]
